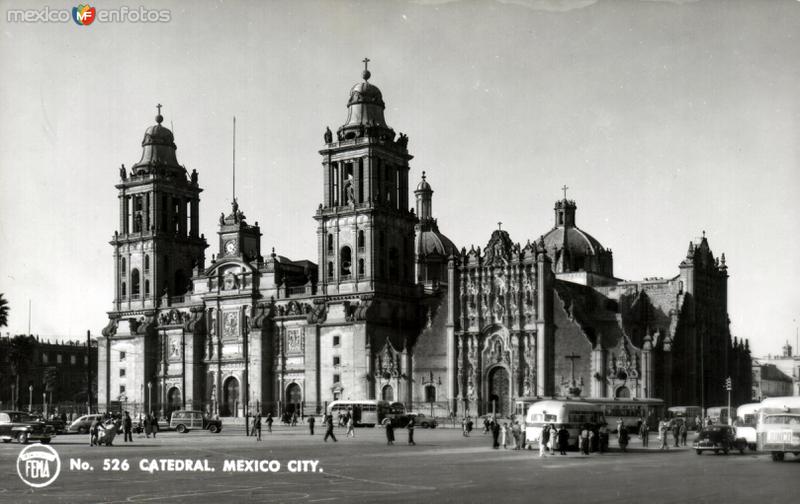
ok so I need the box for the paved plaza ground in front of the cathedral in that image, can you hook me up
[0,425,800,504]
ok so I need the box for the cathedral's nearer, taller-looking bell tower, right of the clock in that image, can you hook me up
[314,58,417,295]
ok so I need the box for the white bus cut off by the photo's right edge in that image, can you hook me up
[756,396,800,462]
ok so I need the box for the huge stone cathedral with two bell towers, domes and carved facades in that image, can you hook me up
[98,64,750,416]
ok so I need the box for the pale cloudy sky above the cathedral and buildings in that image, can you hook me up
[0,0,800,356]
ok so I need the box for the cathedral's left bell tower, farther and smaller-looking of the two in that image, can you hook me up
[111,104,208,311]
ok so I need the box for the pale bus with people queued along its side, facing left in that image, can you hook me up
[525,399,605,447]
